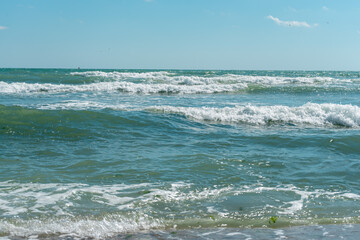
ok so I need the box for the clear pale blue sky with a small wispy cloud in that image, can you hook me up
[0,0,360,71]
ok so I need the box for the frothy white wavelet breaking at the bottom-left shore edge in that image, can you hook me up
[0,214,163,239]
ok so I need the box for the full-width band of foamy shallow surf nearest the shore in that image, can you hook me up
[0,182,360,238]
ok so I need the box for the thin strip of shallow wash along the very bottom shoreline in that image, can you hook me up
[0,224,360,240]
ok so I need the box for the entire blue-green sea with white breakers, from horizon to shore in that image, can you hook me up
[0,69,360,239]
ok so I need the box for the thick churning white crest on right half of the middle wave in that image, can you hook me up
[147,103,360,128]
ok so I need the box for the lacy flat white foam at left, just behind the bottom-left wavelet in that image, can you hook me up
[0,182,231,216]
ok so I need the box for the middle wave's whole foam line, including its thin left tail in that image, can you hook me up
[36,101,360,128]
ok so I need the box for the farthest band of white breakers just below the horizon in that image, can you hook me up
[0,71,360,94]
